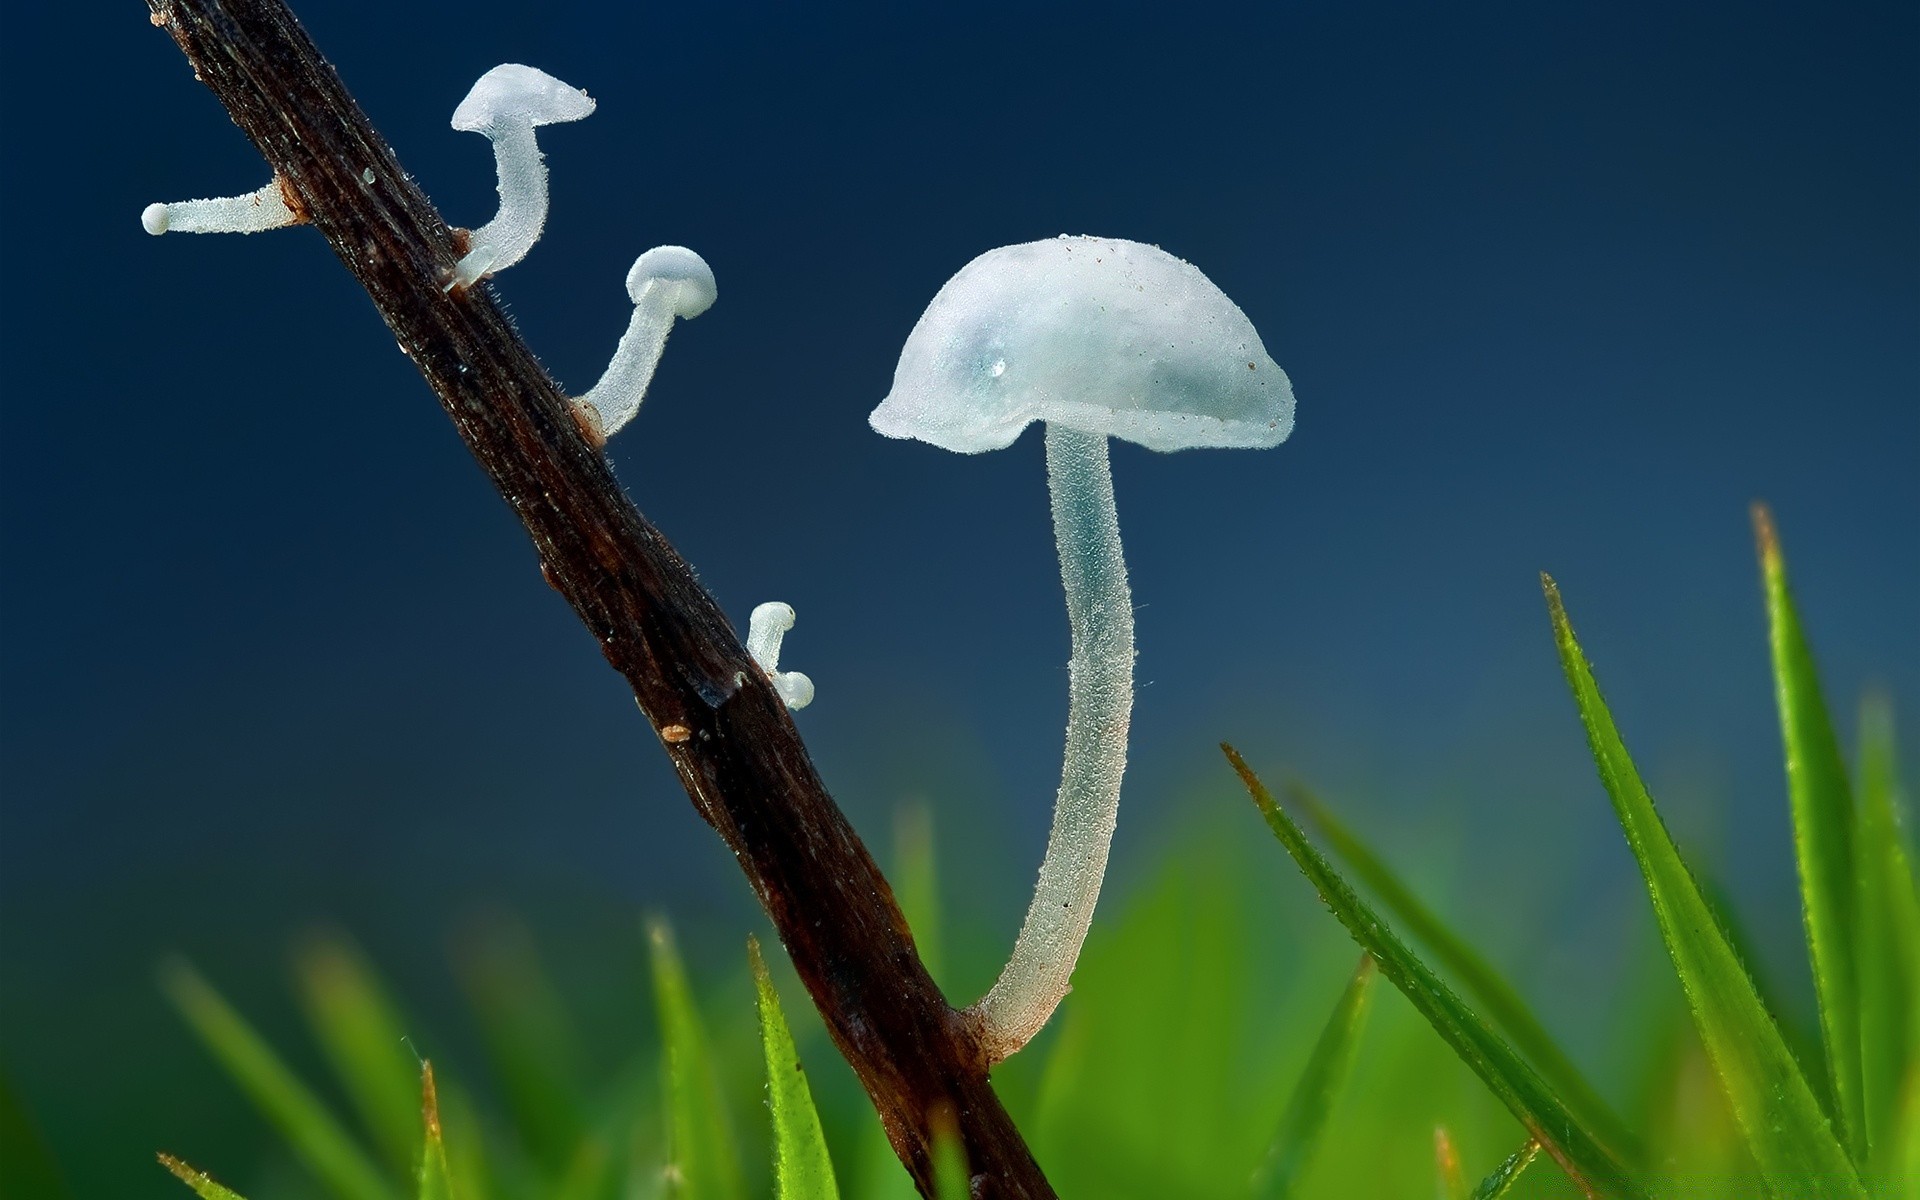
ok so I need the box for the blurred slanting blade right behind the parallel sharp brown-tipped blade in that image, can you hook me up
[1286,781,1645,1164]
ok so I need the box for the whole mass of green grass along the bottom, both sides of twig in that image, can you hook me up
[33,506,1920,1200]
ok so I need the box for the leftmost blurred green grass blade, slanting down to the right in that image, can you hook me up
[161,960,394,1200]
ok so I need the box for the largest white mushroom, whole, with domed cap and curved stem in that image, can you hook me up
[868,236,1294,1062]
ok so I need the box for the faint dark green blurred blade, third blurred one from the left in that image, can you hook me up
[459,920,588,1179]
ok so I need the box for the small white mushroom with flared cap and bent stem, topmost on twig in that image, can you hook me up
[449,63,593,290]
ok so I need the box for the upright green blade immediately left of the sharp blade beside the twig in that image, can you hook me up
[647,922,747,1200]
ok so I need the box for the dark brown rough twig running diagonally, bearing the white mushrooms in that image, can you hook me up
[148,0,1054,1198]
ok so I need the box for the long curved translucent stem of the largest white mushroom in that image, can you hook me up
[966,422,1133,1064]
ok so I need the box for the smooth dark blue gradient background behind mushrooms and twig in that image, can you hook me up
[0,0,1920,1194]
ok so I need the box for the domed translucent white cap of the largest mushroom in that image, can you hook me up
[868,234,1294,453]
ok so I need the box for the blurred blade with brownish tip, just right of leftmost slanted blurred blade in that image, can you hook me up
[294,933,420,1175]
